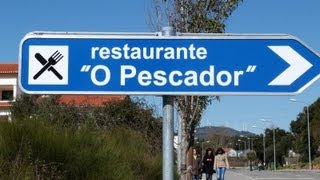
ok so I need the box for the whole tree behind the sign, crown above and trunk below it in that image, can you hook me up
[149,0,242,179]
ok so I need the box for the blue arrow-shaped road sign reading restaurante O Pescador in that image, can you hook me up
[19,32,320,95]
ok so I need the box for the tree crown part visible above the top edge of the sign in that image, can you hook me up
[171,0,242,33]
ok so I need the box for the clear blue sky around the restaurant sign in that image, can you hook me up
[0,0,320,133]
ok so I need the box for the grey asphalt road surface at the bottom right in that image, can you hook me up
[201,169,320,180]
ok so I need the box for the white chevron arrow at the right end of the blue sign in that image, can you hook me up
[268,46,312,86]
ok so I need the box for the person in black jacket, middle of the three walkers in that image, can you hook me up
[202,148,214,180]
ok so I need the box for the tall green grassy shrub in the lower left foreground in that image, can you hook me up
[0,118,161,180]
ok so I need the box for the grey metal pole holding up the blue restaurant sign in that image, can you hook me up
[161,27,175,180]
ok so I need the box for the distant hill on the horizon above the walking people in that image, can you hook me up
[195,126,254,139]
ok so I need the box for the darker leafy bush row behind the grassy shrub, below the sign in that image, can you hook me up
[11,94,162,152]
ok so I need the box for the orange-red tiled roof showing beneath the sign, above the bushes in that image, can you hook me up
[59,95,126,106]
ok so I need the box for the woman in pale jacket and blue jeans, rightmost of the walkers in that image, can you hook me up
[213,147,229,180]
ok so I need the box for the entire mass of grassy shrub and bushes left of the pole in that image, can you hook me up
[4,94,162,179]
